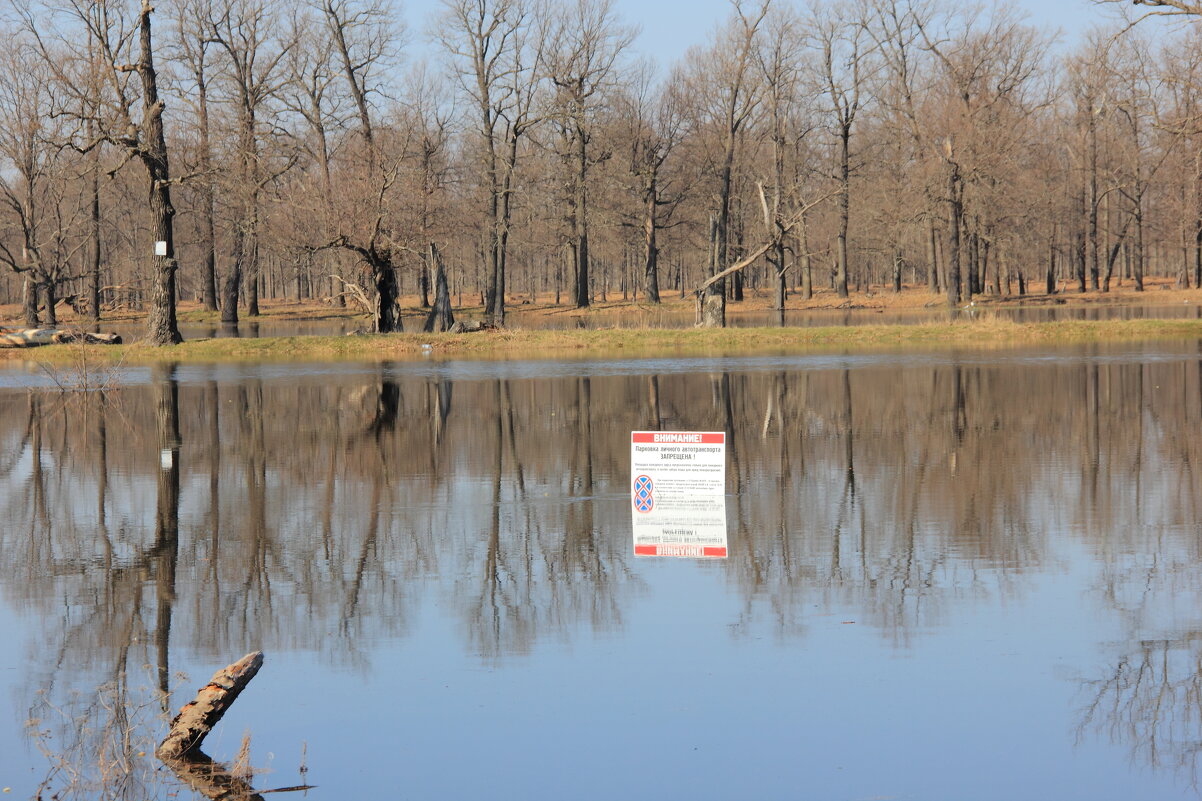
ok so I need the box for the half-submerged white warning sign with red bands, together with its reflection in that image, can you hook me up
[630,431,727,558]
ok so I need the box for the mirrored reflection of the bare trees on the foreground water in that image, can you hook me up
[7,351,1202,797]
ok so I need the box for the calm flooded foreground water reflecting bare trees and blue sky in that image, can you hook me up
[0,343,1202,801]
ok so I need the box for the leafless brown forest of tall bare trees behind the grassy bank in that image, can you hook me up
[0,0,1202,334]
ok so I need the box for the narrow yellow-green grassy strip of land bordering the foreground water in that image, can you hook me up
[0,320,1202,364]
